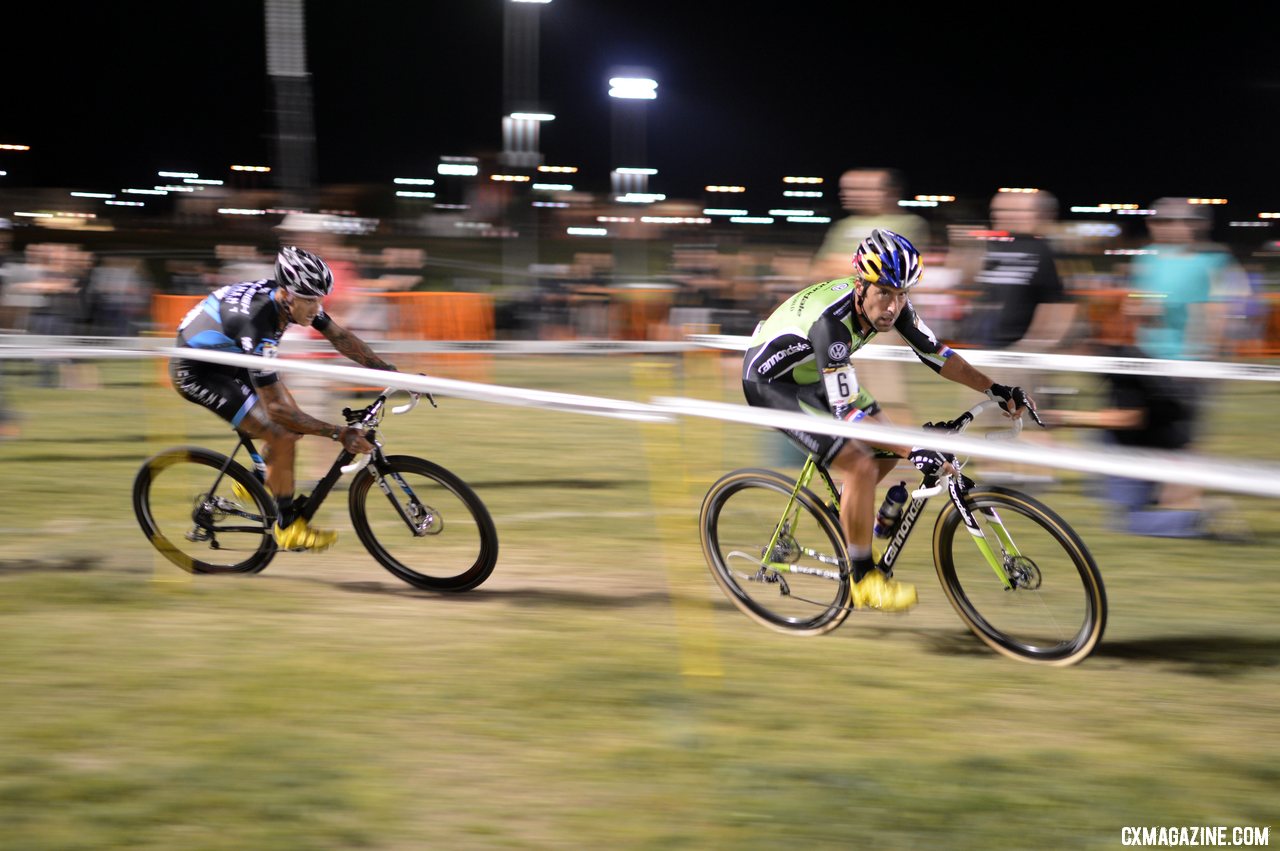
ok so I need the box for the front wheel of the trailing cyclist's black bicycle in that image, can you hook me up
[348,456,498,591]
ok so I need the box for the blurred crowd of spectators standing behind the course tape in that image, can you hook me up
[0,174,1280,536]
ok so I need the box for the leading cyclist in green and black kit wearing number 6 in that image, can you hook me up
[742,228,1043,612]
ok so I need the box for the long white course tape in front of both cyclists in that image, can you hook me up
[0,346,1280,497]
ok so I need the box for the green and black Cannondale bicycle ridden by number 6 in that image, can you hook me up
[699,401,1107,665]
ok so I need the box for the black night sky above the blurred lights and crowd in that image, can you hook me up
[0,0,1280,215]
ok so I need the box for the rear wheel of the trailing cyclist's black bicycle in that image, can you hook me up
[133,447,276,573]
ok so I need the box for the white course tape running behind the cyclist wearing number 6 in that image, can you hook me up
[685,334,1280,381]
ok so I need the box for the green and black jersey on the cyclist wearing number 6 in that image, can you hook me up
[742,278,951,399]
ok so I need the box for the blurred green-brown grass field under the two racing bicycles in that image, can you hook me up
[0,356,1280,851]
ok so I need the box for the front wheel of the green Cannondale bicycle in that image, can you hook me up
[933,485,1107,665]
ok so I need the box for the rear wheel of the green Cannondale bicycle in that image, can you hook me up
[699,468,851,636]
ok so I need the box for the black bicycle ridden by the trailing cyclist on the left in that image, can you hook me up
[133,388,498,591]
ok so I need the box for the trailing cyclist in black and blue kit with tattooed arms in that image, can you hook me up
[170,246,396,550]
